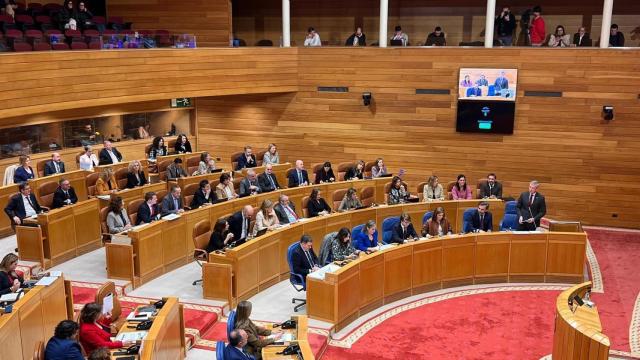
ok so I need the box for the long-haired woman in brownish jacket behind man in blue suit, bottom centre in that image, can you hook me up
[231,300,282,360]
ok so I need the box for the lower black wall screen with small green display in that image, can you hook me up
[456,100,516,134]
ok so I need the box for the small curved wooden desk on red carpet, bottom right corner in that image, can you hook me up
[552,281,611,360]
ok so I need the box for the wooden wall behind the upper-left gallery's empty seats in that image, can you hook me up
[107,0,231,46]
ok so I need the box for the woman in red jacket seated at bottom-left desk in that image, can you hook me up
[80,303,135,356]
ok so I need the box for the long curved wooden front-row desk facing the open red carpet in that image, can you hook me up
[307,232,586,331]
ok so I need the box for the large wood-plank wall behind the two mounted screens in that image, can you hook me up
[197,48,640,228]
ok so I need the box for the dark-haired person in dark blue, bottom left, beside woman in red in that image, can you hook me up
[44,320,84,360]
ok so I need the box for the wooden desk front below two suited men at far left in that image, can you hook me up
[16,199,102,269]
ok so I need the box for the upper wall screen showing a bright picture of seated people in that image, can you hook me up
[458,68,518,101]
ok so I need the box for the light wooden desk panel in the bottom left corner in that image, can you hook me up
[0,277,71,360]
